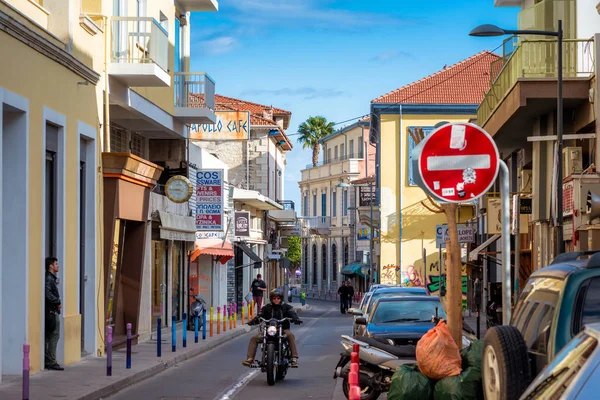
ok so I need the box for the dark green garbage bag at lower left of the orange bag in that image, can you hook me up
[388,365,433,400]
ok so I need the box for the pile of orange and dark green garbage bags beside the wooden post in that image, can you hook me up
[388,321,483,400]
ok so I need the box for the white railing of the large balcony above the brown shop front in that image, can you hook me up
[111,17,169,72]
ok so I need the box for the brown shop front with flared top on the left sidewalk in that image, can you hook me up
[102,153,163,348]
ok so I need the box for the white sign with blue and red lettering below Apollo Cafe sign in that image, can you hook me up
[196,169,224,232]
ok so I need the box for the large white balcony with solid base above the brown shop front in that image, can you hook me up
[109,17,171,87]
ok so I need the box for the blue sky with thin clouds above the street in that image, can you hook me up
[191,0,519,206]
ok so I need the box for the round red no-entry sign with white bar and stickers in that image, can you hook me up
[418,123,500,203]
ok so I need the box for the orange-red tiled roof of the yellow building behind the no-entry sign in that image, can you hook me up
[372,51,500,104]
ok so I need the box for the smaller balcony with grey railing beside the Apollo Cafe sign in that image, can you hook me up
[173,72,217,125]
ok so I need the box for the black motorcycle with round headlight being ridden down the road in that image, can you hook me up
[252,317,300,386]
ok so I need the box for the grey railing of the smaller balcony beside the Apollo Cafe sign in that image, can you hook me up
[174,72,215,110]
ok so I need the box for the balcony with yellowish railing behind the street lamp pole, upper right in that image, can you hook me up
[477,39,595,131]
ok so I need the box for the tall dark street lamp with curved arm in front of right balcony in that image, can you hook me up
[469,19,565,254]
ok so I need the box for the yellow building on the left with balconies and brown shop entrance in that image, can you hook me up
[0,0,218,382]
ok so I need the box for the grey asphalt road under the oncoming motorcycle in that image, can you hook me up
[110,299,352,400]
